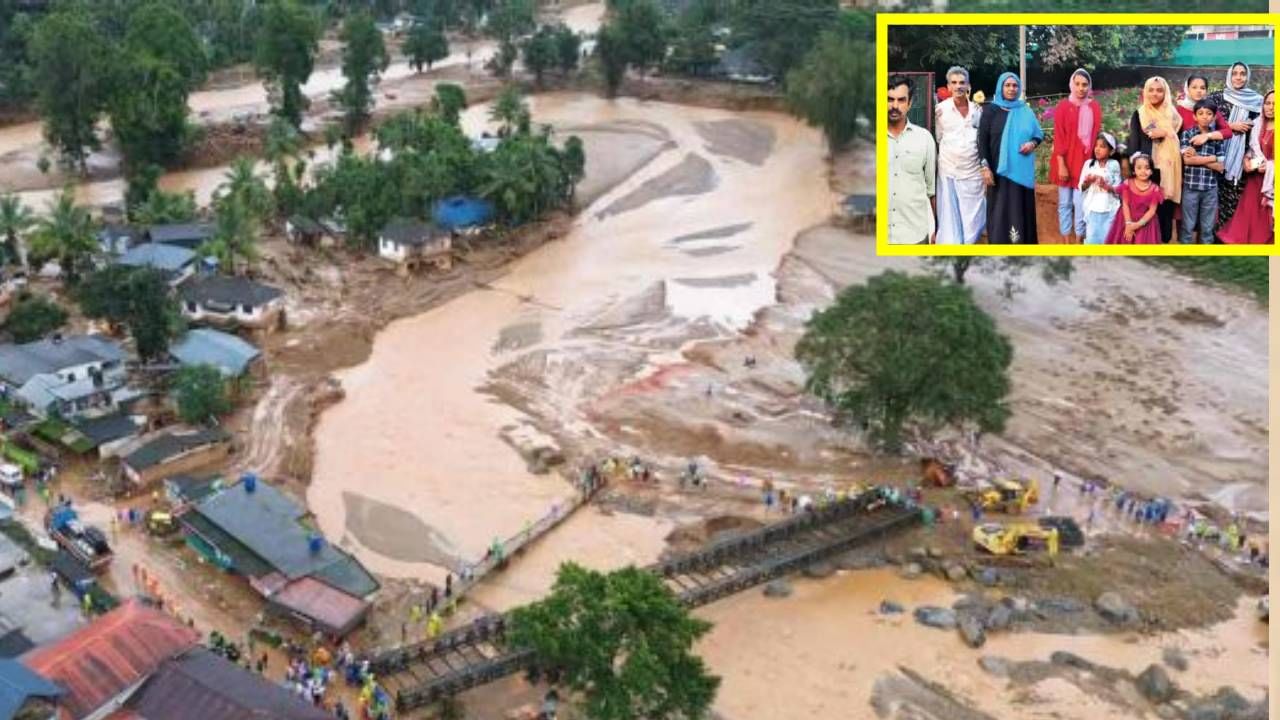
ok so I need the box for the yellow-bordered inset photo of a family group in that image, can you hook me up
[878,15,1276,254]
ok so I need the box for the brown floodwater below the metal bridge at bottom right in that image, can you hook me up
[698,570,1268,720]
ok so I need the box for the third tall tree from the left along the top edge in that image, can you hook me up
[255,0,320,127]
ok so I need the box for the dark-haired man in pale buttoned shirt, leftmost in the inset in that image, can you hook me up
[888,76,938,245]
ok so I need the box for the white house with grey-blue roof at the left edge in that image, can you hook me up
[0,334,136,418]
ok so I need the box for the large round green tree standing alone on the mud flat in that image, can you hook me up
[796,272,1014,451]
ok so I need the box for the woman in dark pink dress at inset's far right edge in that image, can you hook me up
[1217,91,1276,245]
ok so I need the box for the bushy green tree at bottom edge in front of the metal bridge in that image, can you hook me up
[511,562,719,720]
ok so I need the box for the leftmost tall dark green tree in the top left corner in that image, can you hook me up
[31,5,115,174]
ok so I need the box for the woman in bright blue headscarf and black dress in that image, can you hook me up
[978,73,1044,245]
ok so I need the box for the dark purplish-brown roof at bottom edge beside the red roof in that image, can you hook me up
[125,647,333,720]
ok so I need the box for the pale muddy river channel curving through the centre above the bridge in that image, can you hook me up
[308,95,835,579]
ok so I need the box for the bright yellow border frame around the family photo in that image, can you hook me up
[876,13,1280,256]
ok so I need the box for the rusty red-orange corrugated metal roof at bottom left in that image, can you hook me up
[22,600,200,720]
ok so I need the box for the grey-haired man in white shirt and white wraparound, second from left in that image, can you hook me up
[933,65,987,245]
